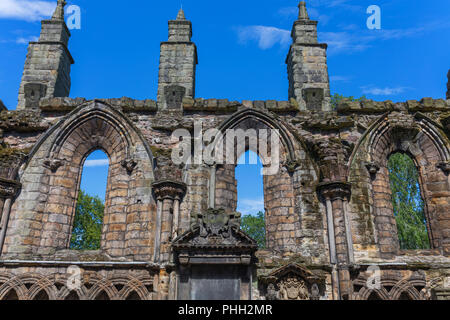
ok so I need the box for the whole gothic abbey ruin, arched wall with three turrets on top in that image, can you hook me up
[0,0,450,300]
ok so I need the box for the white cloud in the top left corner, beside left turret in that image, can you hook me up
[0,0,56,21]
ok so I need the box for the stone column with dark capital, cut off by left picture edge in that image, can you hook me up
[0,178,22,255]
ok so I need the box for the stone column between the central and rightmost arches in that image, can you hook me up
[318,182,354,299]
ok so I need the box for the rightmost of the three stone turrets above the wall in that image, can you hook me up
[286,1,330,110]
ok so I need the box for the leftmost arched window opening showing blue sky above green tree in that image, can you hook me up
[70,150,109,250]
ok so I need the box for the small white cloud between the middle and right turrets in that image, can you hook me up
[238,26,291,50]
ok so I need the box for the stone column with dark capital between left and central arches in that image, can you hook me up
[153,180,186,263]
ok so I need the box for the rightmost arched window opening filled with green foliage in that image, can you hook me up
[388,153,430,250]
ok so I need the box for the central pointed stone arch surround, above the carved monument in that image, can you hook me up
[203,109,325,256]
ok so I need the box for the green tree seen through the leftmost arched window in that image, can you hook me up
[70,190,105,250]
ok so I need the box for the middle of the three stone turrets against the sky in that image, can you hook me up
[158,9,197,109]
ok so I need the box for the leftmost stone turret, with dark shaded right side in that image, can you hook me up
[17,0,74,109]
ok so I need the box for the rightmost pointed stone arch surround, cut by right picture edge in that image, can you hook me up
[349,114,450,258]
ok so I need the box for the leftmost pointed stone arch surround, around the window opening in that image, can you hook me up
[6,101,155,259]
